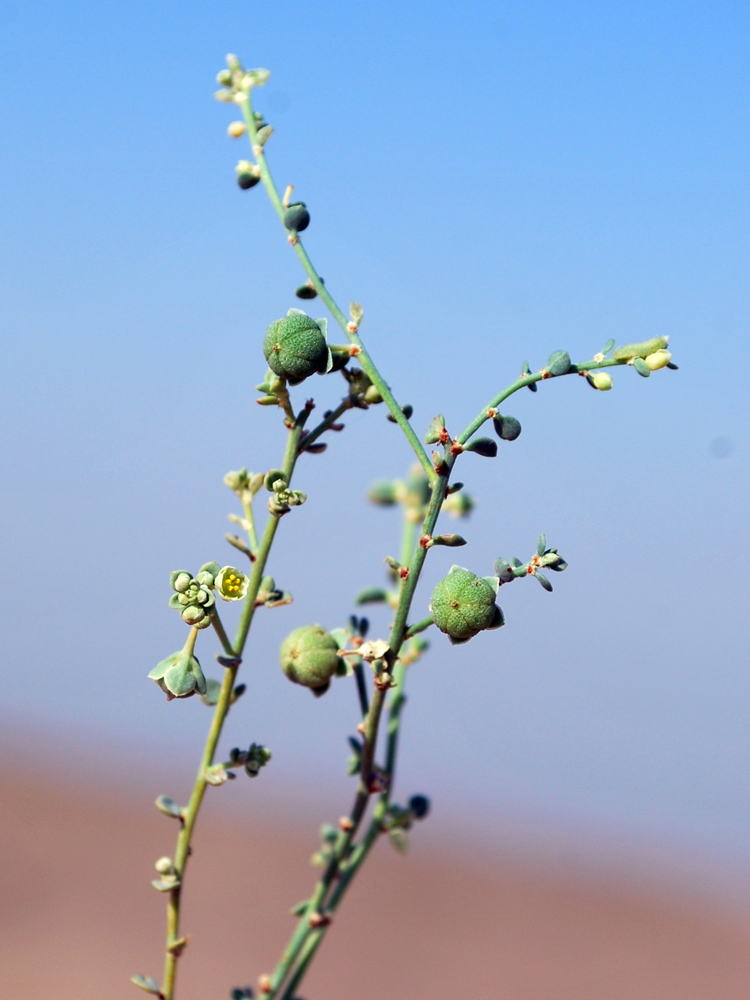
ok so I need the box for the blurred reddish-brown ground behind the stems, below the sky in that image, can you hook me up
[0,760,750,1000]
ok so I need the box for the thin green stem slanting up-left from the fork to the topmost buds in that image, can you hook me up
[241,96,435,483]
